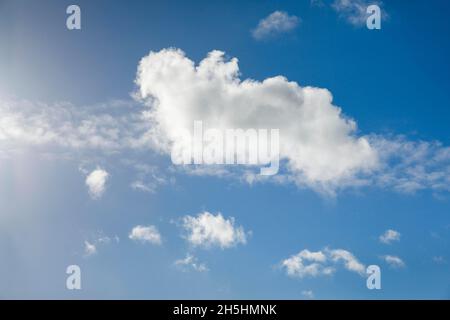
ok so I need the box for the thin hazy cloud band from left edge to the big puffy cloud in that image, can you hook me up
[0,99,149,153]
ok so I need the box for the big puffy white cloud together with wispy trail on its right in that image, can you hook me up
[136,49,450,195]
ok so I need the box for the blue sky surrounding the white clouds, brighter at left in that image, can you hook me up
[0,0,450,299]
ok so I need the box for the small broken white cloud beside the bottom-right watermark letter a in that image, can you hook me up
[281,248,365,278]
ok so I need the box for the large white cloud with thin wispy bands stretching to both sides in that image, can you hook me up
[0,49,450,196]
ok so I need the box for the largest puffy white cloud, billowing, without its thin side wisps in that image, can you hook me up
[136,49,378,193]
